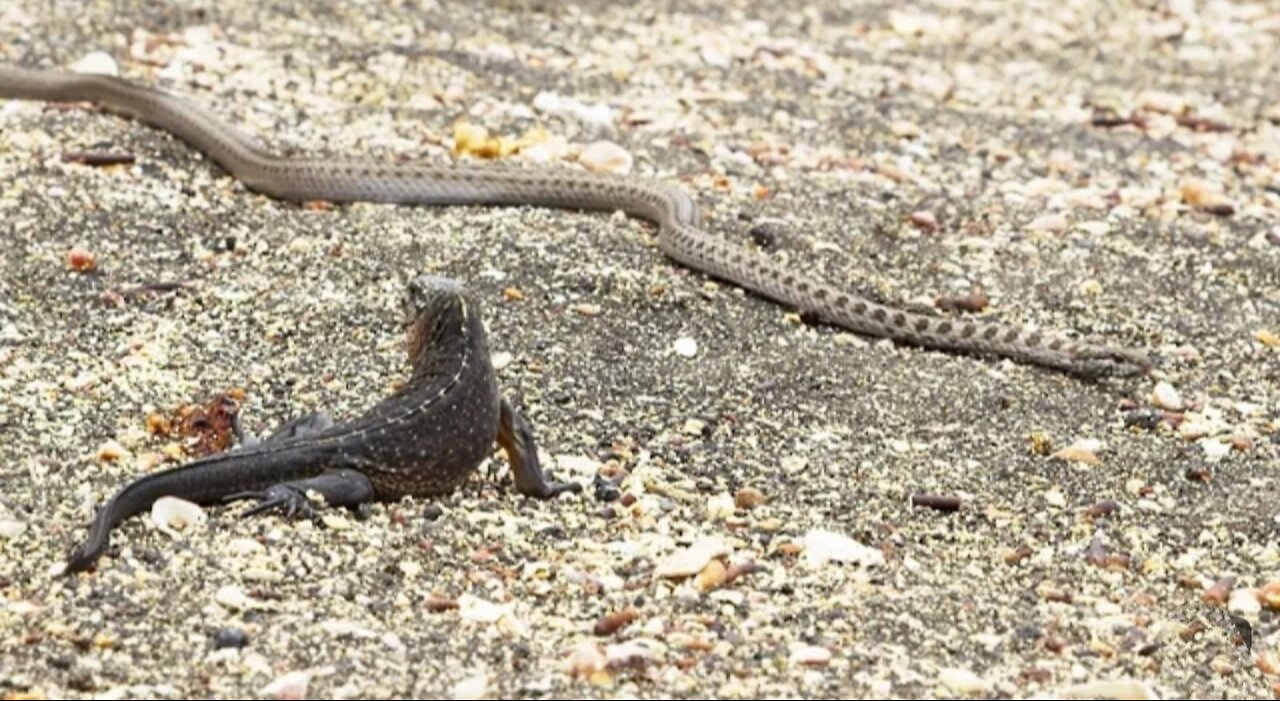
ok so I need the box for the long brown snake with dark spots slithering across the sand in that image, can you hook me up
[0,65,1151,377]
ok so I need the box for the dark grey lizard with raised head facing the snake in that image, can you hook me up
[67,276,581,572]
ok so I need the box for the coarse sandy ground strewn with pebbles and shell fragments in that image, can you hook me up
[0,0,1280,698]
